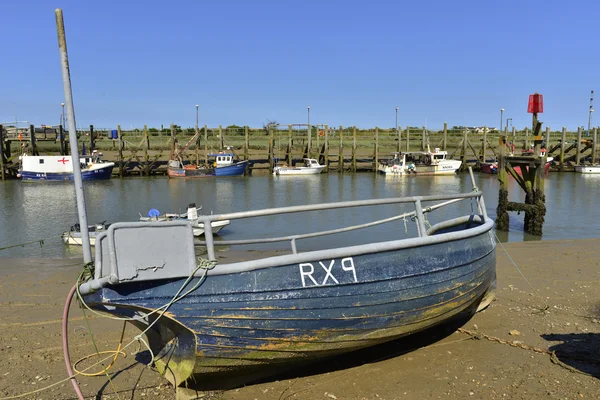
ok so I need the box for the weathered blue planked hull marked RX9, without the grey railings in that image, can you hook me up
[85,230,496,385]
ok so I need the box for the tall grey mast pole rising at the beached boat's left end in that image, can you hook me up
[54,8,92,264]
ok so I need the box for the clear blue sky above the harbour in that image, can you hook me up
[0,0,600,129]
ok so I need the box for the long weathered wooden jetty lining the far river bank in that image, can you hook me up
[0,123,598,179]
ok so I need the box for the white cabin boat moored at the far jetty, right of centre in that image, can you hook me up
[377,148,461,175]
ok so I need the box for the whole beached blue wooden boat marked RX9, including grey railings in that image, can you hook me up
[79,191,496,386]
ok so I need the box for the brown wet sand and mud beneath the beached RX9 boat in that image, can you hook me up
[0,239,600,400]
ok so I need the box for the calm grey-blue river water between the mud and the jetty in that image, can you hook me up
[0,173,600,257]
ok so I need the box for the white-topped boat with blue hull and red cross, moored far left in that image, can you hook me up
[17,151,115,182]
